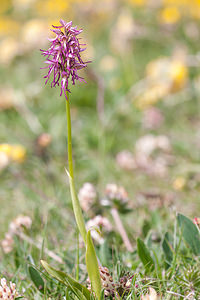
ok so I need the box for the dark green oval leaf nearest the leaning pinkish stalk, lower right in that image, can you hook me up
[137,238,155,272]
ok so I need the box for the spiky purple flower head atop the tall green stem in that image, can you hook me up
[41,20,88,99]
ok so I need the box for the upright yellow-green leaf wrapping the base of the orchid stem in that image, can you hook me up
[86,230,102,299]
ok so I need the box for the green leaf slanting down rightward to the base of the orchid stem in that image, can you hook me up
[41,260,91,300]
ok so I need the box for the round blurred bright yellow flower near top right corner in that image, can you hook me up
[160,6,181,24]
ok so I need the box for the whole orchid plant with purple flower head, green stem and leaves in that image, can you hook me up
[41,20,102,299]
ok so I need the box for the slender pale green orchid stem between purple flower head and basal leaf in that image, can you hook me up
[66,100,87,244]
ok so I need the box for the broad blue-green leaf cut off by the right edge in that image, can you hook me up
[177,214,200,255]
